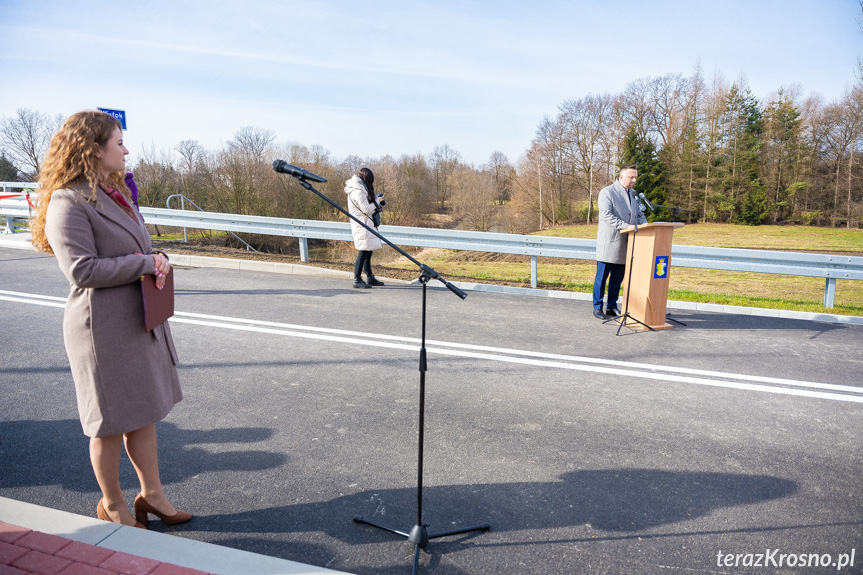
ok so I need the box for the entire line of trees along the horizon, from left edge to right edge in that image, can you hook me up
[0,66,863,233]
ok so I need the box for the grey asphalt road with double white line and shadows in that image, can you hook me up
[0,249,863,574]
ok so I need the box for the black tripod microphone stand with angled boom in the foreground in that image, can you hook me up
[277,170,491,575]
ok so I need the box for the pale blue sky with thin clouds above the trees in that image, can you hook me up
[0,0,863,165]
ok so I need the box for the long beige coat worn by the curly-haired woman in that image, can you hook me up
[45,186,183,437]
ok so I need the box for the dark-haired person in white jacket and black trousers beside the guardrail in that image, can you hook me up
[345,168,384,289]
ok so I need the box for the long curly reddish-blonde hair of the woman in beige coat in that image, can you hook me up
[30,110,132,254]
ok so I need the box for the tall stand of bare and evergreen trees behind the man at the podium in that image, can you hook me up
[519,68,863,228]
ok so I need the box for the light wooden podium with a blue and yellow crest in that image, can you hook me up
[620,222,683,330]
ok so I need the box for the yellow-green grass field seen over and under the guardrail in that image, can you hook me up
[388,224,863,316]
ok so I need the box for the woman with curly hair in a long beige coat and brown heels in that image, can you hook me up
[31,111,191,527]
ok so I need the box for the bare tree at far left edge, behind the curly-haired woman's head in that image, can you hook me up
[0,108,63,180]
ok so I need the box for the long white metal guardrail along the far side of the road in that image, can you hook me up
[0,182,863,308]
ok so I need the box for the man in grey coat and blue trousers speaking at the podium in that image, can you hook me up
[593,164,647,319]
